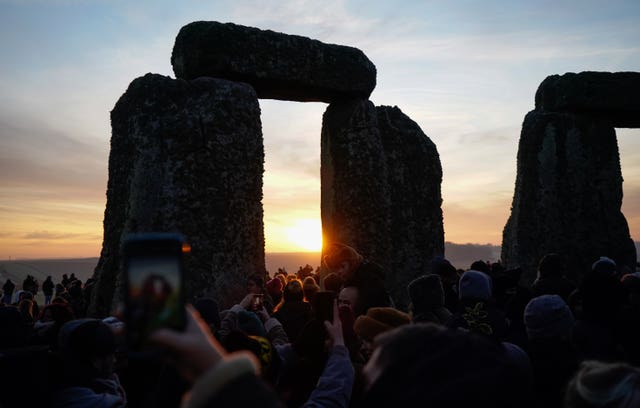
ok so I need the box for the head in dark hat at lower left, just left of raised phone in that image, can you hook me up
[58,319,116,381]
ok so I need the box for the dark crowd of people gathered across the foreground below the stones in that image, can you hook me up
[0,244,640,408]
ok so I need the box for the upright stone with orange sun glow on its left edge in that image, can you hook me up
[320,99,391,270]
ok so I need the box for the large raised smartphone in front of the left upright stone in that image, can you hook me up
[122,233,189,350]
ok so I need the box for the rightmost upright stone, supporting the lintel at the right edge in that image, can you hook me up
[502,111,636,283]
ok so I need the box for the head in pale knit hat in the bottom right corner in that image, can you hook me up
[564,361,640,408]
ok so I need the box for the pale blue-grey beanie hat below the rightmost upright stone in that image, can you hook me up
[524,295,575,339]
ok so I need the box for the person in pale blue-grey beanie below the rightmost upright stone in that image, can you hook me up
[524,295,579,407]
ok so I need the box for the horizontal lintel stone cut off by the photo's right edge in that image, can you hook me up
[536,72,640,127]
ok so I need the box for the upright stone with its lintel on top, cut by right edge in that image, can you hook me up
[502,72,640,284]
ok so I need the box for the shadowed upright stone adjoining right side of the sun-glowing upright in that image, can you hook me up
[376,106,444,308]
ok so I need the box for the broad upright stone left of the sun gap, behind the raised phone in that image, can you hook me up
[90,74,264,316]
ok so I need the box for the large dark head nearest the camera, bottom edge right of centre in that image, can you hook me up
[362,323,529,408]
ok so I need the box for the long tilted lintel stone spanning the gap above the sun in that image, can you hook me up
[171,21,376,102]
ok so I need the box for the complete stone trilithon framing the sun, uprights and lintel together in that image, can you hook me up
[90,22,444,316]
